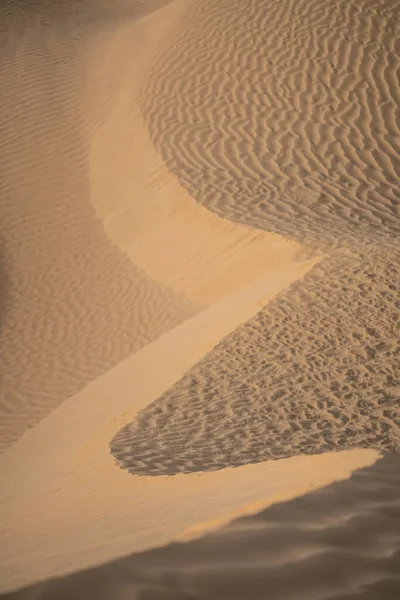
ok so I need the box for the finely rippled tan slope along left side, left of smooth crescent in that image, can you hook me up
[0,2,193,449]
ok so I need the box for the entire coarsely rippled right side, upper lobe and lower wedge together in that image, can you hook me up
[111,0,400,475]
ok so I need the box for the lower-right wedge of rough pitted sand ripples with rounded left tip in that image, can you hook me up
[111,252,400,475]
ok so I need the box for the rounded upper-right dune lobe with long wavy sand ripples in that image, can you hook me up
[141,0,400,248]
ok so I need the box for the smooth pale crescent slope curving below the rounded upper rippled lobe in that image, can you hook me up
[87,2,310,306]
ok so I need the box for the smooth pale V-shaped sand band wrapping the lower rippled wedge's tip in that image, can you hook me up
[0,294,379,592]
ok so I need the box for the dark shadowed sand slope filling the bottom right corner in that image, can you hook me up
[6,454,400,600]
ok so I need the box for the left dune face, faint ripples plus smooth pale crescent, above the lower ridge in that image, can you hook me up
[0,3,310,449]
